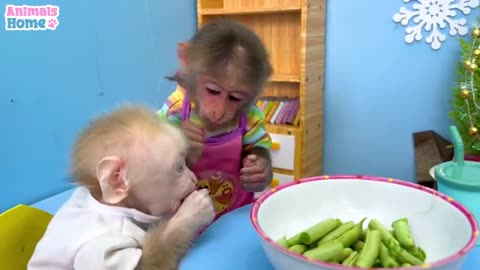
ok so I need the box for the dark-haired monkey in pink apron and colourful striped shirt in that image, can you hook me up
[158,19,272,218]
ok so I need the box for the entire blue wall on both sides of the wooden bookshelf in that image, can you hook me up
[0,0,480,211]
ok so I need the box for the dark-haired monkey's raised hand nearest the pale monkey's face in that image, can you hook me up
[181,120,206,167]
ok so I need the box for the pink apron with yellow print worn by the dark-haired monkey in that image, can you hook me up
[182,97,254,220]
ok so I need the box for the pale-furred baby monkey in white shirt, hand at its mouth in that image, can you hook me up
[28,105,215,270]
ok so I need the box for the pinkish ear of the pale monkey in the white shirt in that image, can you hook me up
[97,156,129,204]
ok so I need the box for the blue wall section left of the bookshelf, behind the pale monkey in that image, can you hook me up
[0,0,196,211]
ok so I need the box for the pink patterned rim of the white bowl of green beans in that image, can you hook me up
[250,175,479,270]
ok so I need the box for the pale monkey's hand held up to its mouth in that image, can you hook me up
[169,189,215,231]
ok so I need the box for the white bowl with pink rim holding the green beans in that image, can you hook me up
[250,176,478,270]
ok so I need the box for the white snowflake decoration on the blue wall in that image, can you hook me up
[393,0,479,50]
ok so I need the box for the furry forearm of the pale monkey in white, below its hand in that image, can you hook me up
[135,221,195,270]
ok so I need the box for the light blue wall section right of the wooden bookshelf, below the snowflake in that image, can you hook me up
[324,0,478,181]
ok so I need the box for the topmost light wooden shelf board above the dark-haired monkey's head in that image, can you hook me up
[202,6,302,16]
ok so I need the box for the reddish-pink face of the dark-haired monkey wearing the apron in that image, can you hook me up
[196,74,251,128]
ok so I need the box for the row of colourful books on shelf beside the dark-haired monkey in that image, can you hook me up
[257,97,300,126]
